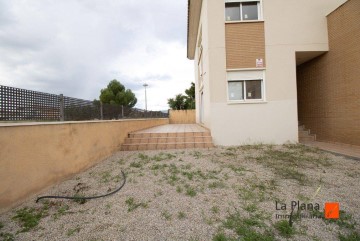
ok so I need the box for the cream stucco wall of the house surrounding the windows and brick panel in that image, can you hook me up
[195,0,345,145]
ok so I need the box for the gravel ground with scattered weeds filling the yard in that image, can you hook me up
[0,145,360,241]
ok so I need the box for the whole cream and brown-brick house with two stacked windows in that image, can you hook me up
[187,0,360,146]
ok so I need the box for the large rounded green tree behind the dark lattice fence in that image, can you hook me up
[100,79,137,107]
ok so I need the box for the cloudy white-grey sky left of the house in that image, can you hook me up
[0,0,194,110]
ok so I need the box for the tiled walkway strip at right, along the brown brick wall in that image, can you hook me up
[303,141,360,160]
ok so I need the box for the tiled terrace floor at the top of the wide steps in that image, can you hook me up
[134,124,209,134]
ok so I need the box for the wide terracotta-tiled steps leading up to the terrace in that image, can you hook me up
[121,131,214,151]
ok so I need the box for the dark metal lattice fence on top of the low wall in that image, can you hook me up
[0,85,169,121]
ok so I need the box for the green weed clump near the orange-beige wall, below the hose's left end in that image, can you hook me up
[13,207,47,232]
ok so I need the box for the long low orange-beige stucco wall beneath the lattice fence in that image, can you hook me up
[0,119,169,212]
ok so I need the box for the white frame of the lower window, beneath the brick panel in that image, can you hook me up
[226,69,266,104]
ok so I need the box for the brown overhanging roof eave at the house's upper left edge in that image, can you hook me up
[187,0,202,60]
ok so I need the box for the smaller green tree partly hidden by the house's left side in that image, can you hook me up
[168,82,195,110]
